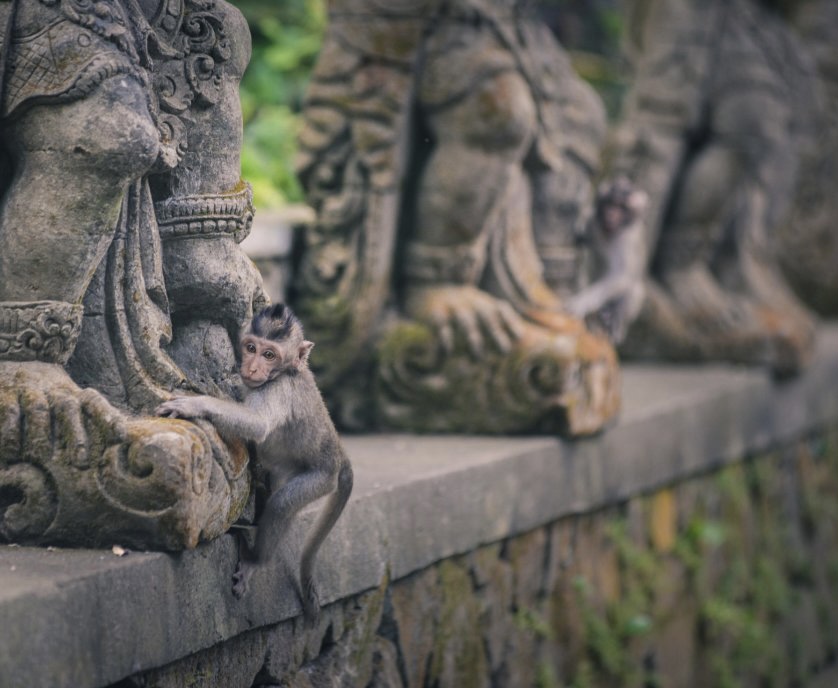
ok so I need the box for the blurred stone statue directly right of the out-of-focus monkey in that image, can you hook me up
[616,0,814,374]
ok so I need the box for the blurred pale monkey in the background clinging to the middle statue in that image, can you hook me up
[567,176,649,343]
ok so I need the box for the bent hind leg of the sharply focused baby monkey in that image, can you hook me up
[233,471,337,598]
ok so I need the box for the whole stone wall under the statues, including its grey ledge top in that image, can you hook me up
[0,326,838,688]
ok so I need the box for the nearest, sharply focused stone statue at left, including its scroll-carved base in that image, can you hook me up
[0,0,265,549]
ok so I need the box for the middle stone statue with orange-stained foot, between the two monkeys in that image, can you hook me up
[292,0,618,435]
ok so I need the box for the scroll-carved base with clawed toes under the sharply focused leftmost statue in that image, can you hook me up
[0,362,250,550]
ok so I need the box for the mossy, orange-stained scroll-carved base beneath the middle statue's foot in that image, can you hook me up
[375,316,619,436]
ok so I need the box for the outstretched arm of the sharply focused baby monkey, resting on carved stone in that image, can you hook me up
[155,395,278,443]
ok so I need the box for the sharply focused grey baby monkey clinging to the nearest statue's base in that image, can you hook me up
[157,304,353,621]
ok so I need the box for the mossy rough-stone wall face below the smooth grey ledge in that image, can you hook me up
[114,426,838,688]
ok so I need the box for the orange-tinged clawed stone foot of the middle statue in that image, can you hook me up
[405,285,524,357]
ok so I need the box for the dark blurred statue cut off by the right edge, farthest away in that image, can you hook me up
[778,0,838,317]
